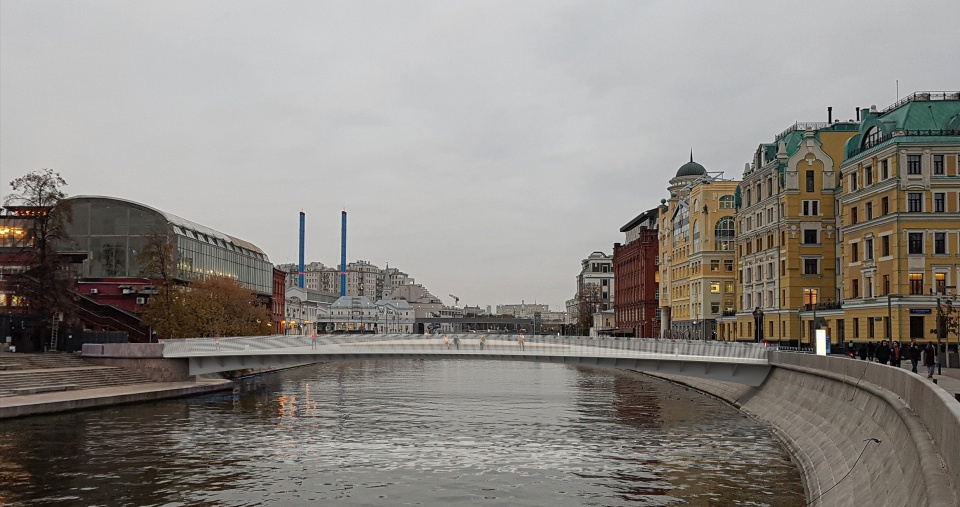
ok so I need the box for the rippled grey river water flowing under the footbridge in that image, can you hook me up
[0,360,804,506]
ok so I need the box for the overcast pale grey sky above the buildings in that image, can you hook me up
[0,0,960,309]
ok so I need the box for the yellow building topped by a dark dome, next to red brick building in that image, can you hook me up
[659,155,738,339]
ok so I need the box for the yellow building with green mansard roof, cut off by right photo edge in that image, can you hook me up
[837,92,960,342]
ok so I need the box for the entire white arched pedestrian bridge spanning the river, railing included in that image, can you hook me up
[161,333,771,387]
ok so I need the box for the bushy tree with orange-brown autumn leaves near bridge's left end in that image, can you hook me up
[142,277,270,338]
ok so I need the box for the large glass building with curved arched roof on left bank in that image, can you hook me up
[67,196,273,295]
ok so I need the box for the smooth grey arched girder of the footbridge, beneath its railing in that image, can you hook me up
[189,352,771,387]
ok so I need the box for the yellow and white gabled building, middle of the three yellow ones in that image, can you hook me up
[720,122,858,343]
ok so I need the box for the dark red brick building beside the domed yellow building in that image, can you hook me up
[613,208,660,338]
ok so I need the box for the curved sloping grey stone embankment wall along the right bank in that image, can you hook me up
[640,352,960,507]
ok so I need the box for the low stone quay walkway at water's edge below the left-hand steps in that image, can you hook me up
[0,379,232,419]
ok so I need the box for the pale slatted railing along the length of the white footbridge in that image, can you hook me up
[161,333,769,360]
